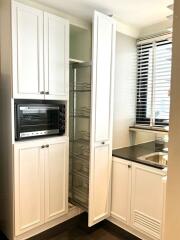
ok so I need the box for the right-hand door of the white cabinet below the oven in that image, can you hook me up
[45,139,68,222]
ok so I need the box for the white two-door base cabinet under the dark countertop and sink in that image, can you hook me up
[111,157,167,240]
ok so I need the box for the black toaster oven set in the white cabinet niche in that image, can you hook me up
[15,103,66,141]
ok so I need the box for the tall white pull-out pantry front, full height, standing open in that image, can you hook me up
[88,11,116,226]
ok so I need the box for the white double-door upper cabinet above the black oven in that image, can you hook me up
[12,1,69,100]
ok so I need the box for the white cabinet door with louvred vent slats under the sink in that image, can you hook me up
[131,164,166,239]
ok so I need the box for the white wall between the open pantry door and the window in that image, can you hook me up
[113,33,136,148]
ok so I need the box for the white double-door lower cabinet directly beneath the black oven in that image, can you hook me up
[14,138,68,236]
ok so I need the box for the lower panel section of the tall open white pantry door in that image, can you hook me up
[89,143,112,227]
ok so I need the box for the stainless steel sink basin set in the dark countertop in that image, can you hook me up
[139,152,168,166]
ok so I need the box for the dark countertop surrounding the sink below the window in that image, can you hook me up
[112,141,165,169]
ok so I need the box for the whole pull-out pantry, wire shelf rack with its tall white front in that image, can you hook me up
[69,12,116,226]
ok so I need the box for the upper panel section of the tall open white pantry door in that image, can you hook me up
[92,12,116,142]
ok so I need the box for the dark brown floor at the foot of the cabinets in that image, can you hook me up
[0,215,139,240]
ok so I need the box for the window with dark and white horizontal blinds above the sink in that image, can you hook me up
[136,34,172,126]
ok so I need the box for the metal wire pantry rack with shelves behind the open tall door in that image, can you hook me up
[70,63,91,209]
